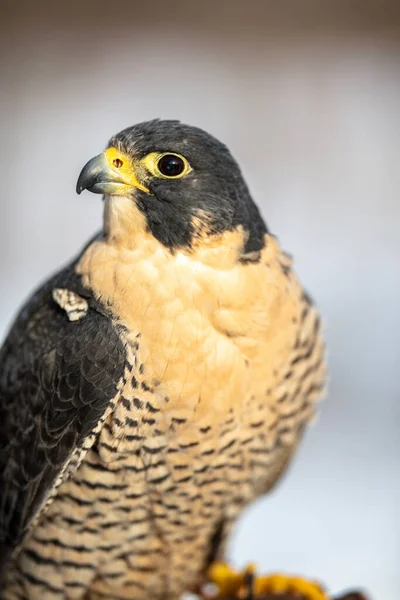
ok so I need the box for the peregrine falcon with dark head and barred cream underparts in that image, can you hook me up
[0,120,325,600]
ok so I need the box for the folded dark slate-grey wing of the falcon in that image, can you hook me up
[0,265,125,571]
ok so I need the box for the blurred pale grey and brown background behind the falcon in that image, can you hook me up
[0,0,400,600]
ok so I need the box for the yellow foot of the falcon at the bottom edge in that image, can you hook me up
[203,563,329,600]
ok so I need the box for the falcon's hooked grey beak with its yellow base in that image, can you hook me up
[76,148,149,196]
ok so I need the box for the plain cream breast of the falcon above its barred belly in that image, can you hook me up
[78,224,298,419]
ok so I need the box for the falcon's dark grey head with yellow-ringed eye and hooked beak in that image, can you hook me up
[77,120,266,253]
